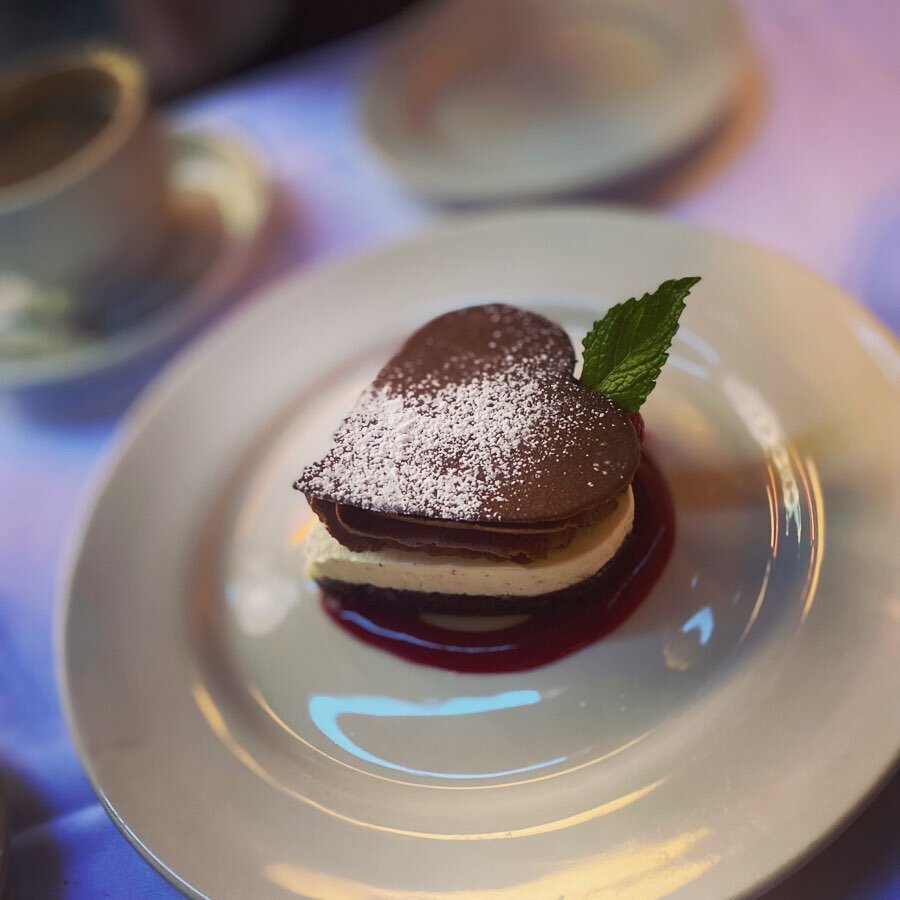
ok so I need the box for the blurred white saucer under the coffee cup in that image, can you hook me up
[0,131,272,394]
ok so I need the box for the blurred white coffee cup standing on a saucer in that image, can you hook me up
[0,46,169,318]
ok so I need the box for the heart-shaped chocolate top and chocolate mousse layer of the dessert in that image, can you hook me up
[294,304,640,562]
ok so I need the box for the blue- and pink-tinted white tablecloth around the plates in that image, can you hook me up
[0,0,900,900]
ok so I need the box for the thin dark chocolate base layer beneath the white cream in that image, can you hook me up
[318,535,631,616]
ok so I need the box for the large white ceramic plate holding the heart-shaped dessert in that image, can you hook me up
[59,209,900,900]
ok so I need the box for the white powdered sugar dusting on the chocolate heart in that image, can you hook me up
[297,358,613,521]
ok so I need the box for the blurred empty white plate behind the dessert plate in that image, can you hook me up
[362,0,748,201]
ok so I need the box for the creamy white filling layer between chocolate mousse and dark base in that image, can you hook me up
[306,487,634,596]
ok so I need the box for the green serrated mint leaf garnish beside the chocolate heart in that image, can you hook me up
[581,278,700,413]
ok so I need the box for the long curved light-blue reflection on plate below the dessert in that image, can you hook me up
[309,690,566,779]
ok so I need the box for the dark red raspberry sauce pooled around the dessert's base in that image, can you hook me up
[322,453,675,673]
